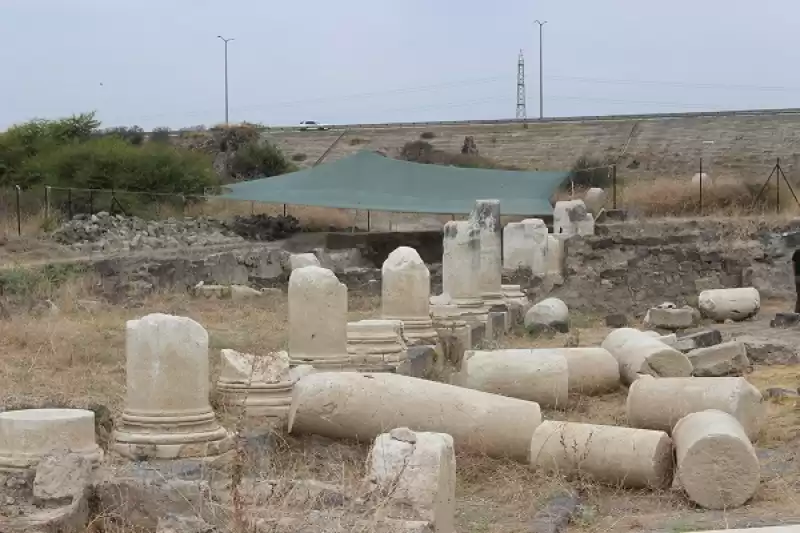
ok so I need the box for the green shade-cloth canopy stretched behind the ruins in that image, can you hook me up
[221,151,569,215]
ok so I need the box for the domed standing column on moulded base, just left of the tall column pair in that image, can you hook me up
[381,246,437,345]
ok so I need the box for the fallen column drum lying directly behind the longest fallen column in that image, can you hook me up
[457,349,569,409]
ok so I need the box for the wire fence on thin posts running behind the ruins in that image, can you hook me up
[0,159,800,236]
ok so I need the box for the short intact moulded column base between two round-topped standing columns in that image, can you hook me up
[347,320,408,367]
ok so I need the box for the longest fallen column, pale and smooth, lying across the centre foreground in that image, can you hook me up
[289,372,541,460]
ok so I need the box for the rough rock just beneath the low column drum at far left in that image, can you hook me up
[33,452,92,504]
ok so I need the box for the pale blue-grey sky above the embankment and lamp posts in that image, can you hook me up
[0,0,800,130]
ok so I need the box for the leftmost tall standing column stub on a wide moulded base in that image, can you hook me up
[113,313,233,459]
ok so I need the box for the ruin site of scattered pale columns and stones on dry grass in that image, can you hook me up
[0,117,800,533]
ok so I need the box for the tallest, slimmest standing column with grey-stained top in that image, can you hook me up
[469,200,505,307]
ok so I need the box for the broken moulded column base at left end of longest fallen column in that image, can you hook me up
[216,349,296,422]
